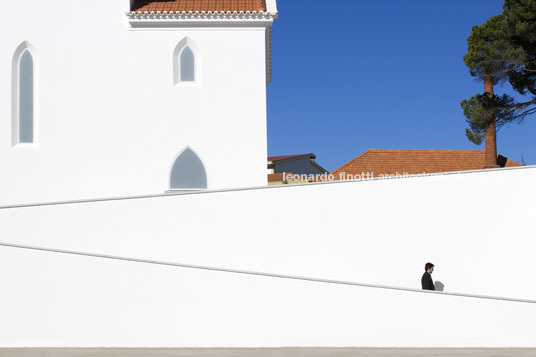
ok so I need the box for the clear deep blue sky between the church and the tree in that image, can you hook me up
[268,0,536,170]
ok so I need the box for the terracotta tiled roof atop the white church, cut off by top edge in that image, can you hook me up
[132,0,266,12]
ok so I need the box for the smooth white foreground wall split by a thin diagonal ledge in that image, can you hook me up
[0,167,536,347]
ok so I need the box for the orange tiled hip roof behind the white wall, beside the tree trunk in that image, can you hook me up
[332,149,522,179]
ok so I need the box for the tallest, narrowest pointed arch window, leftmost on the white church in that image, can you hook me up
[12,43,35,145]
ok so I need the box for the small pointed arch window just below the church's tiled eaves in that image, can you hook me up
[173,37,200,85]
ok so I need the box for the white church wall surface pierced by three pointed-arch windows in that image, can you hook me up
[0,0,267,204]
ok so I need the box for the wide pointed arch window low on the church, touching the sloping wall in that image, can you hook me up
[169,147,207,190]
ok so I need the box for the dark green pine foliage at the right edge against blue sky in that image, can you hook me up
[461,0,536,145]
